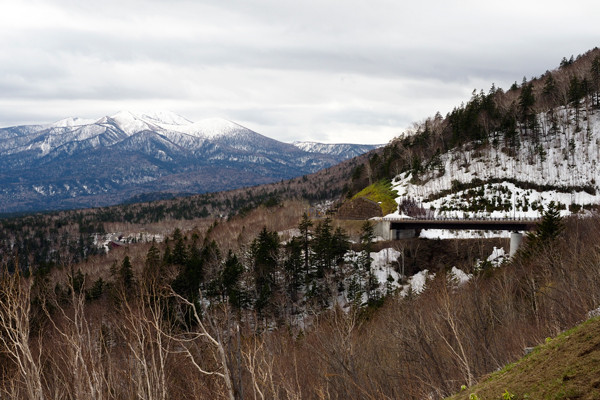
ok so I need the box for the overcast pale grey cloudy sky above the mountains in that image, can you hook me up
[0,0,600,143]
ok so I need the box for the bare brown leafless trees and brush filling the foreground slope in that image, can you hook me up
[0,211,600,399]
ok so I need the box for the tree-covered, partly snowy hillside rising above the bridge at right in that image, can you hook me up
[346,49,600,222]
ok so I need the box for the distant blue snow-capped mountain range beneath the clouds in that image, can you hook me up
[0,111,372,212]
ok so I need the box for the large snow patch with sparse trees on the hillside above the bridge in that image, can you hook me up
[390,109,600,218]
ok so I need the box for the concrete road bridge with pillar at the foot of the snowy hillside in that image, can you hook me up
[374,218,540,256]
